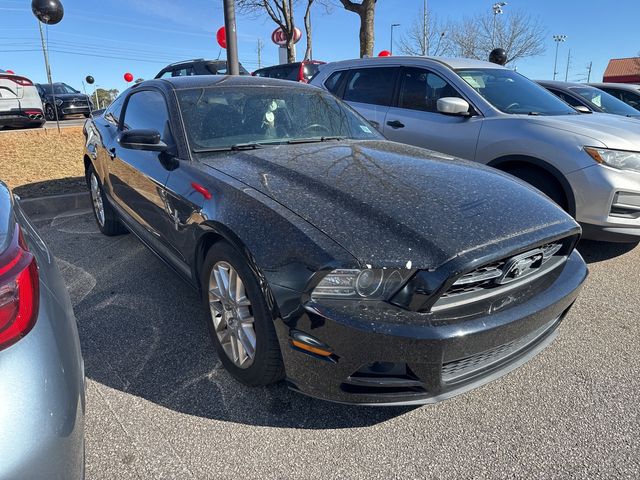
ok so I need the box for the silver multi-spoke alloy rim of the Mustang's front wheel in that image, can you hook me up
[209,261,256,368]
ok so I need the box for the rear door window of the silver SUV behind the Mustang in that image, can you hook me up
[344,67,398,107]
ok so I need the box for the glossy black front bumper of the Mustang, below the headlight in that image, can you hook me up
[276,251,587,405]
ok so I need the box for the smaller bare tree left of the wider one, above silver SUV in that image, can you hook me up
[398,12,452,57]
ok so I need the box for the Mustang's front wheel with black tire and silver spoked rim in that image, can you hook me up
[201,242,284,386]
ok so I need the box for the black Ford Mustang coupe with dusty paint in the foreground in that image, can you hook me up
[84,76,587,405]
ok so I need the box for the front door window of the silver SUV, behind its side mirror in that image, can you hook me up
[398,68,461,112]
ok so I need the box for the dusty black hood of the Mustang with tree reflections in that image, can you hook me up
[201,141,578,269]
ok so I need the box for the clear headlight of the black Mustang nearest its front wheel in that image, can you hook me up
[311,269,415,300]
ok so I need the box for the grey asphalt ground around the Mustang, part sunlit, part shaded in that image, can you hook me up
[37,214,640,479]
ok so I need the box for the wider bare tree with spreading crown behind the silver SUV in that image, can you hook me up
[448,10,547,63]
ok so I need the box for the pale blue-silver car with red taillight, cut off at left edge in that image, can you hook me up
[0,182,85,479]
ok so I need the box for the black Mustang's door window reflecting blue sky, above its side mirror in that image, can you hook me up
[124,90,173,145]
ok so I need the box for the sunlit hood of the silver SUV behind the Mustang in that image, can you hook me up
[527,113,640,151]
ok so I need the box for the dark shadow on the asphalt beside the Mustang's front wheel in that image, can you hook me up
[53,215,411,429]
